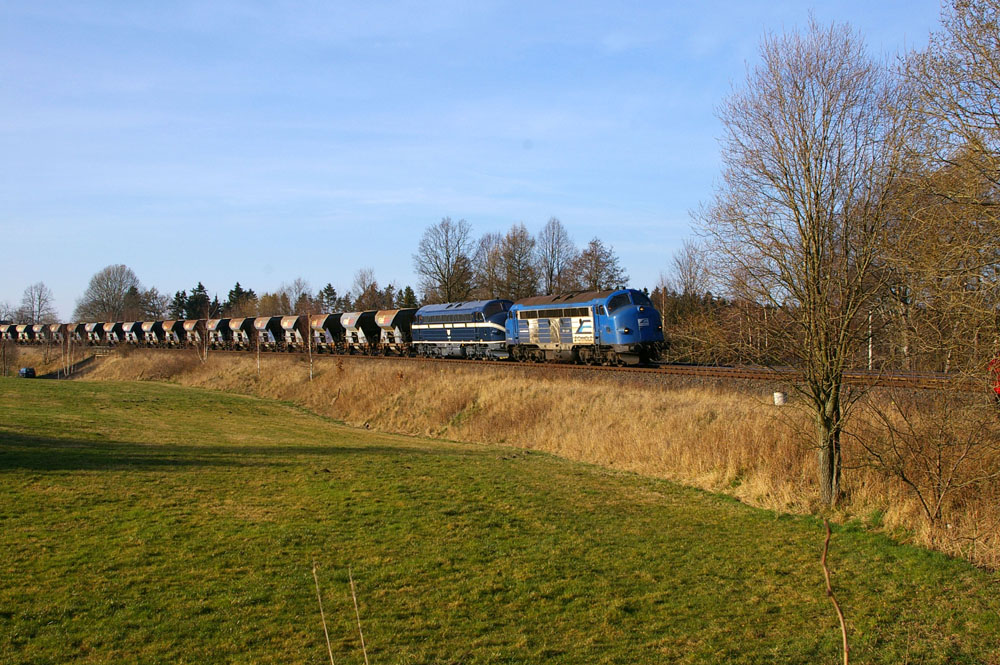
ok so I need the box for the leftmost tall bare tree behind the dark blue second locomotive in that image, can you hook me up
[413,217,472,303]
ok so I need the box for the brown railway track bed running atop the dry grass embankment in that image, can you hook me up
[78,348,978,390]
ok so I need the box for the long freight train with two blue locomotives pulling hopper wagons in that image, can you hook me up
[0,289,663,365]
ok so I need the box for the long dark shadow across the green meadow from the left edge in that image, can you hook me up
[0,431,450,472]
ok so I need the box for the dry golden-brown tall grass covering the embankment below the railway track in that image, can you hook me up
[76,352,1000,567]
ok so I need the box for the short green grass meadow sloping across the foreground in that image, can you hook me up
[0,379,1000,665]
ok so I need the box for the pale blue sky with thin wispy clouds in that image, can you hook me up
[0,0,940,320]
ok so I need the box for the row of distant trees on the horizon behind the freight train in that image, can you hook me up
[0,217,628,323]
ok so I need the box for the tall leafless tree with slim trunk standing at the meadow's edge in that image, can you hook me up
[701,21,905,505]
